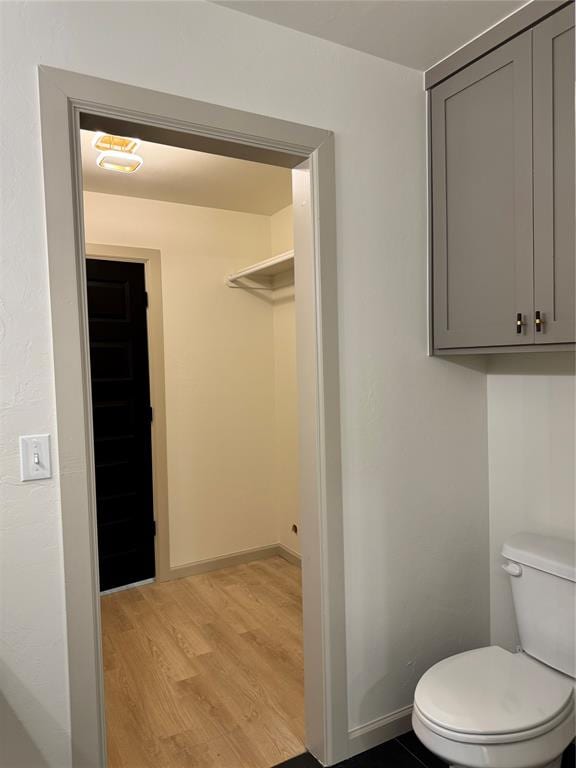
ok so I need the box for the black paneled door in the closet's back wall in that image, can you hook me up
[87,259,154,590]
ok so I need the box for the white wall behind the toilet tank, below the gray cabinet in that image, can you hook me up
[488,352,576,650]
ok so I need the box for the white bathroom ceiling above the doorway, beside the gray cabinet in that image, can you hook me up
[214,0,526,71]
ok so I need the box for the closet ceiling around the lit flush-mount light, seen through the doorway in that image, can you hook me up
[80,130,292,216]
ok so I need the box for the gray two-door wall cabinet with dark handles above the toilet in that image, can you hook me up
[430,5,576,353]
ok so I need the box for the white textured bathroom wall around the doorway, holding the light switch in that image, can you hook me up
[0,2,489,768]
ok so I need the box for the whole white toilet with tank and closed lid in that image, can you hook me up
[412,533,576,768]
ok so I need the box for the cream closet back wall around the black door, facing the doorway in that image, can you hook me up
[84,192,277,567]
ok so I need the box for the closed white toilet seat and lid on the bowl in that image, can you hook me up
[414,646,574,744]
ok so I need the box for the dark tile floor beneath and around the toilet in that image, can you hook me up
[277,731,576,768]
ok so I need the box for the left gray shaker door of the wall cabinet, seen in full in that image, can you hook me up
[431,31,534,349]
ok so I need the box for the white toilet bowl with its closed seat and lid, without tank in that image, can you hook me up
[412,646,574,768]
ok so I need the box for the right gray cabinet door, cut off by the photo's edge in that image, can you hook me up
[533,5,576,344]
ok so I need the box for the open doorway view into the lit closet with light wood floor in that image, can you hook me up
[81,132,305,768]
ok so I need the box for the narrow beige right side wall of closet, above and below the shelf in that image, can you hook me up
[270,205,300,554]
